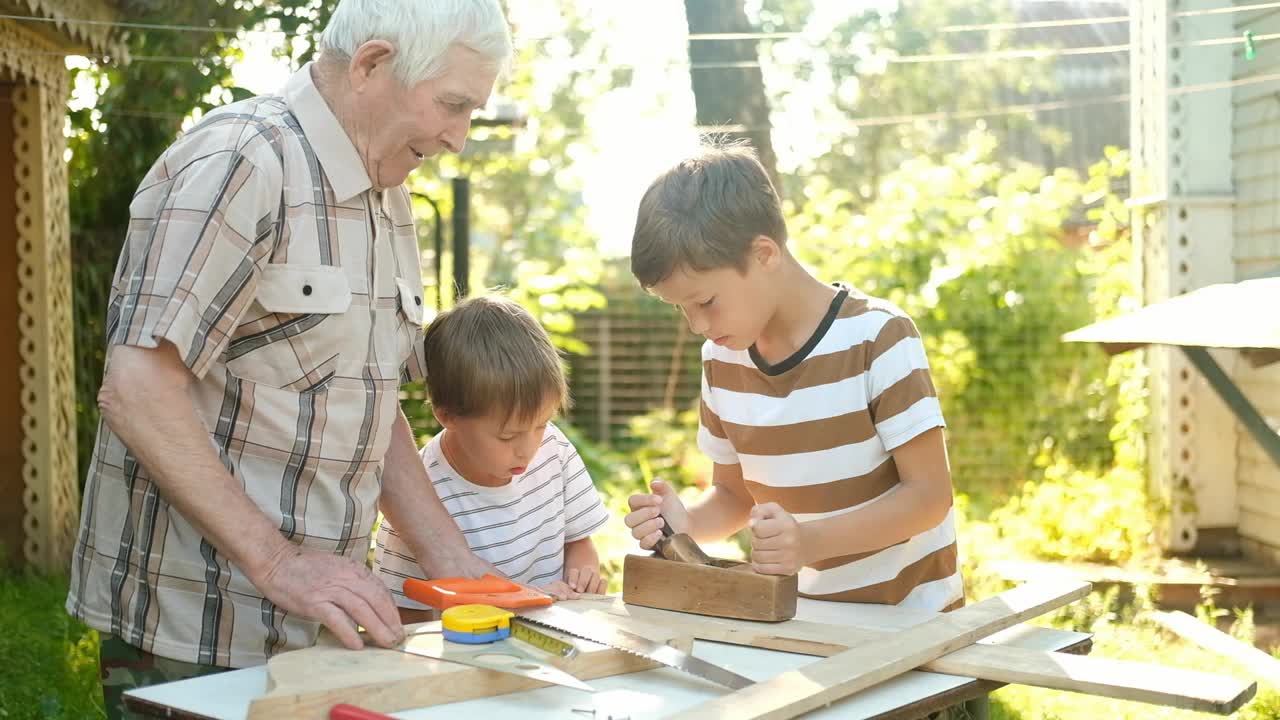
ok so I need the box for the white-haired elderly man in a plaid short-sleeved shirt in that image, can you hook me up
[67,0,511,716]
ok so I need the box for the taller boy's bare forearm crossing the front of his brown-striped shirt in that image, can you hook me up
[800,484,950,565]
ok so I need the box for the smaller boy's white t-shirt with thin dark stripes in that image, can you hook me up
[374,425,609,609]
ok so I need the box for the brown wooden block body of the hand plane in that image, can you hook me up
[622,550,799,623]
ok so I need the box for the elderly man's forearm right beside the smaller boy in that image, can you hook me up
[379,413,495,578]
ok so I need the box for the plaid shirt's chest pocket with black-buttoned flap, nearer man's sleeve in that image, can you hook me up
[227,264,355,392]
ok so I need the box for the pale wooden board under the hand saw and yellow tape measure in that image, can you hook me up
[248,601,692,720]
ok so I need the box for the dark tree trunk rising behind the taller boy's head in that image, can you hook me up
[685,0,782,193]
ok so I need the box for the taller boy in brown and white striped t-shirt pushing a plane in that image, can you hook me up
[626,142,964,610]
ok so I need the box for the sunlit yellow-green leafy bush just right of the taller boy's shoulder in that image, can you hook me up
[791,132,1132,504]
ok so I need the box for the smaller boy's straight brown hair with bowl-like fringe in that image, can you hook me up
[424,295,568,420]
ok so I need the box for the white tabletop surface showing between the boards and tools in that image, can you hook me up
[127,598,1089,720]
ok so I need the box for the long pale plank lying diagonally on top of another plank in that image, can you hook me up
[672,582,1089,720]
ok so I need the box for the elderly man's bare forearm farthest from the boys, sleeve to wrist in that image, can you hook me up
[99,343,292,580]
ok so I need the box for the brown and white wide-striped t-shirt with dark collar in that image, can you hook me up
[698,286,964,610]
